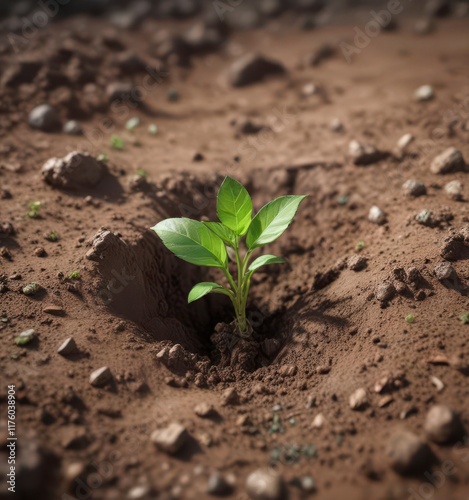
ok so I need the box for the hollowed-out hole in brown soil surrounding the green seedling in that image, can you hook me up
[88,164,332,371]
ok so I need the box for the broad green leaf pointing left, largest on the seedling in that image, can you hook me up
[152,217,228,268]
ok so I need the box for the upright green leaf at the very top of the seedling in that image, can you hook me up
[217,177,252,235]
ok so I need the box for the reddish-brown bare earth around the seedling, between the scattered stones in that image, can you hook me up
[0,8,469,500]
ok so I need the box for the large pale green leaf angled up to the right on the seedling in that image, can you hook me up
[246,196,306,250]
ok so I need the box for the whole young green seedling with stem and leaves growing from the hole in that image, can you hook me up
[152,177,306,337]
